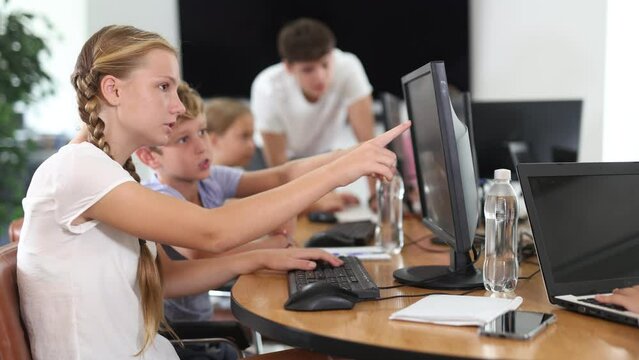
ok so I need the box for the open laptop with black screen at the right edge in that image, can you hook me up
[517,163,639,326]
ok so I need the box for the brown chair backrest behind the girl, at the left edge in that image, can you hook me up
[0,243,31,360]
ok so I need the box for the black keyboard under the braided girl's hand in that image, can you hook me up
[288,256,379,299]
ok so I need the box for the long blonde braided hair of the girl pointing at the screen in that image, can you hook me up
[71,25,177,356]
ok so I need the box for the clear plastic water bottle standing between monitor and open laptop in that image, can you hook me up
[484,169,519,293]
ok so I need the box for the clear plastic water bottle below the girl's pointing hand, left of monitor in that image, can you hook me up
[375,174,404,254]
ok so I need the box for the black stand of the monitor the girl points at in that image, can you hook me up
[393,251,484,290]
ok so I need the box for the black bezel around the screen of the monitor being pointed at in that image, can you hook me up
[401,61,473,252]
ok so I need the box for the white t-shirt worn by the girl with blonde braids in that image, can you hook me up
[17,143,178,360]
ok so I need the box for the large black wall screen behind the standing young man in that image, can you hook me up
[178,0,470,98]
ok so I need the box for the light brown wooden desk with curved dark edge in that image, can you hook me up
[232,215,639,359]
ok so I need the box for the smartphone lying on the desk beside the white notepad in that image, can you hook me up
[479,310,555,340]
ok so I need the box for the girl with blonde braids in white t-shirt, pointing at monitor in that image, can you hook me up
[17,26,408,359]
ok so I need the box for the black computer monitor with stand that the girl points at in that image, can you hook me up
[393,61,483,289]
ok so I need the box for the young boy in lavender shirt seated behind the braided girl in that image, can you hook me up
[136,83,360,321]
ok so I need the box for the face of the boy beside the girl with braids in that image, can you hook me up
[153,114,211,184]
